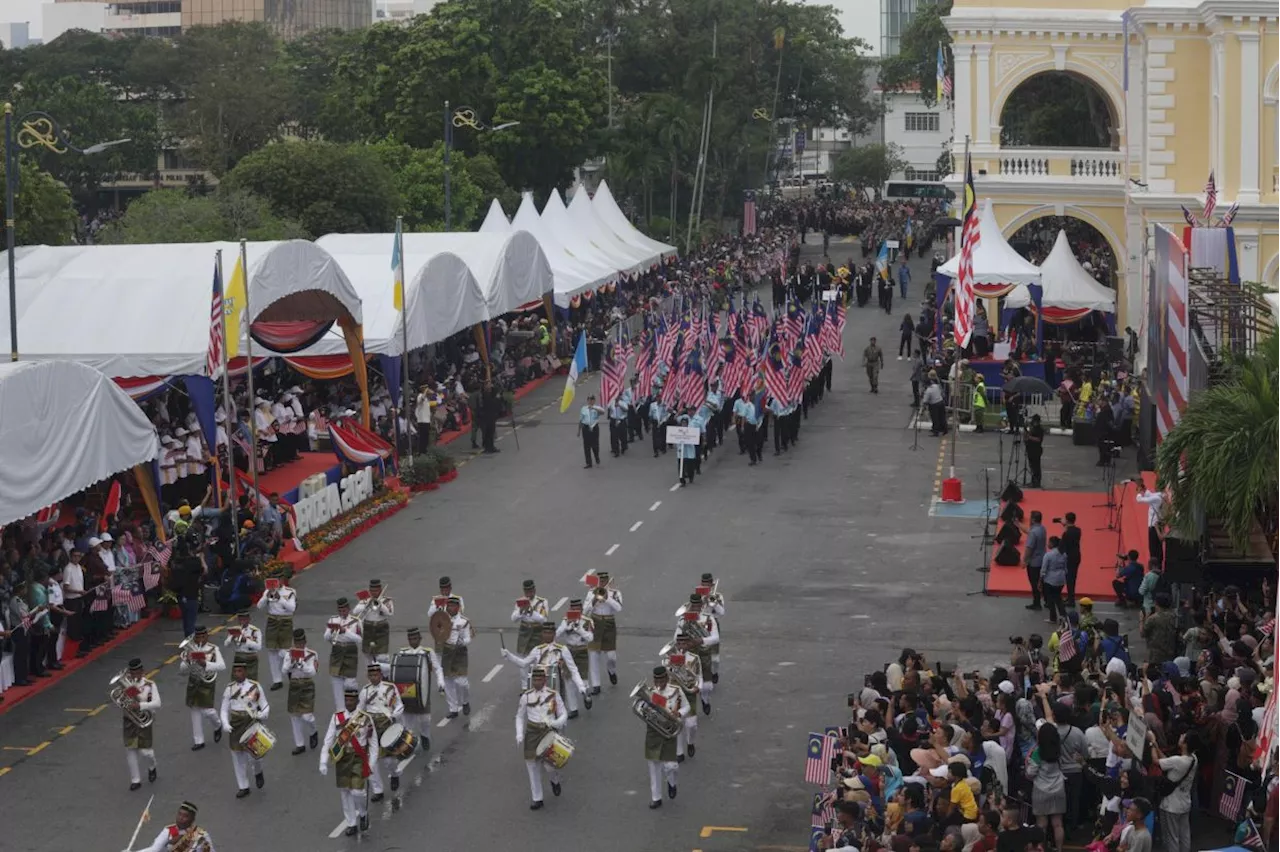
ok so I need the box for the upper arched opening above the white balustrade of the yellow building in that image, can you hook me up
[1000,70,1120,151]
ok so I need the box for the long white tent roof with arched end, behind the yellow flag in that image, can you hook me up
[0,239,362,377]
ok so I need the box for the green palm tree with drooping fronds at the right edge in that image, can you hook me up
[1156,334,1280,550]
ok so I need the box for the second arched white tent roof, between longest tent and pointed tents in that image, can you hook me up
[308,229,553,357]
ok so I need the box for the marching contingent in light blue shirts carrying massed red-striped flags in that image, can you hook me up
[578,285,847,483]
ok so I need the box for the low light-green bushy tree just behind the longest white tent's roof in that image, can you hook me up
[99,189,307,243]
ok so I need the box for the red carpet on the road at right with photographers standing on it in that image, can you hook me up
[987,473,1153,600]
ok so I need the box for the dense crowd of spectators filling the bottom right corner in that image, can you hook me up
[813,583,1280,852]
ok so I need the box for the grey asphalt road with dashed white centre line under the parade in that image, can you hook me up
[0,236,1136,852]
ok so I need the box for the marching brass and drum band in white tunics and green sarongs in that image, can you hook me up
[110,562,724,834]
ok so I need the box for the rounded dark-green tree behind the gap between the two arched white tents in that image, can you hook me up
[221,142,399,237]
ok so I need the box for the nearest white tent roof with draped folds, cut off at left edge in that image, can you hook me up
[0,355,160,526]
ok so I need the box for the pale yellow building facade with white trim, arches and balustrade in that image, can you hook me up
[946,0,1280,329]
